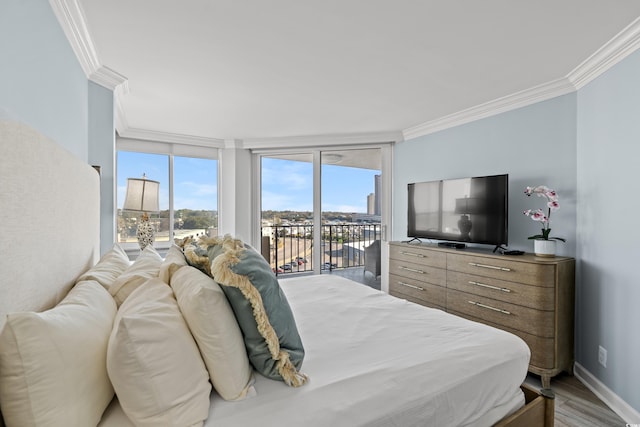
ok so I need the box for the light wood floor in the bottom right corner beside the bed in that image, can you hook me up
[526,373,626,427]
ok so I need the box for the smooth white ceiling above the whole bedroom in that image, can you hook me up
[78,0,640,144]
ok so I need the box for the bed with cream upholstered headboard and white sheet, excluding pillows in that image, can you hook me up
[0,120,553,427]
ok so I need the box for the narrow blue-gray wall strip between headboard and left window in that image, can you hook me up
[88,82,116,253]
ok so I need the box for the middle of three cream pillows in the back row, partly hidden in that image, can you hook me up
[109,246,162,307]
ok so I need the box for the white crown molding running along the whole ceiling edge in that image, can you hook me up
[49,0,640,149]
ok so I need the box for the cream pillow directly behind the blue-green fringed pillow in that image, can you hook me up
[171,266,255,400]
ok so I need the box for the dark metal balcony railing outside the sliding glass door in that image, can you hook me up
[262,224,380,274]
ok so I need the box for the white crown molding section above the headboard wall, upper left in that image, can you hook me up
[49,0,129,93]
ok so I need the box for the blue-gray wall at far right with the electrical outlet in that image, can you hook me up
[576,46,640,412]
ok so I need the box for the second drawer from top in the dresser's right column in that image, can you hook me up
[447,271,555,311]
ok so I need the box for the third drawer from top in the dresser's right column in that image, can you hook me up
[447,289,555,338]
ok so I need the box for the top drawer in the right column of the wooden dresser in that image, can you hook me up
[447,254,555,288]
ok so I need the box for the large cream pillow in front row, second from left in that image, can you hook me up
[107,278,211,427]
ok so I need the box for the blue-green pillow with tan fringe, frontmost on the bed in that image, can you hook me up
[190,235,308,387]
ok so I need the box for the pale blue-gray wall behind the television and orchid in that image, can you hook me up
[393,93,576,256]
